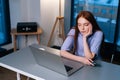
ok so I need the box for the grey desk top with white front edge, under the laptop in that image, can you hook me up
[0,47,120,80]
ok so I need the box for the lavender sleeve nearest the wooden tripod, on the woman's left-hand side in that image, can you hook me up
[61,29,75,51]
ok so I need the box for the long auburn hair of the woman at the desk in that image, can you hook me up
[73,11,101,53]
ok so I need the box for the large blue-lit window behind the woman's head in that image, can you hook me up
[71,0,118,43]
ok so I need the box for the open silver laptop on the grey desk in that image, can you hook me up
[29,44,83,76]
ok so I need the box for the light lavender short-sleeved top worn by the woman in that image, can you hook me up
[61,29,103,56]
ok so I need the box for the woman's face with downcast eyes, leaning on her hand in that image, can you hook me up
[78,17,92,35]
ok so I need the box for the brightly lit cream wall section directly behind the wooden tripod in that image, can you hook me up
[40,0,64,45]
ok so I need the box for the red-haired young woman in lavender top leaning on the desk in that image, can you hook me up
[61,11,103,66]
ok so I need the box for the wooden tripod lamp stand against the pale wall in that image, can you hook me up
[47,0,65,46]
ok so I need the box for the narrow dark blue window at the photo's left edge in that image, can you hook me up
[0,0,11,46]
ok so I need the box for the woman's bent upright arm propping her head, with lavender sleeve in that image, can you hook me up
[83,31,103,59]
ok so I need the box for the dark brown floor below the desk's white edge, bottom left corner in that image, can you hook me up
[0,67,34,80]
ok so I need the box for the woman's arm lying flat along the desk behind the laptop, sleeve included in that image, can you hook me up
[60,29,93,65]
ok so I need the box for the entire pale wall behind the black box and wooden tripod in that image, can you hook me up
[9,0,64,48]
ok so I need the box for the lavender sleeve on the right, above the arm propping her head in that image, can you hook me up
[90,31,103,55]
